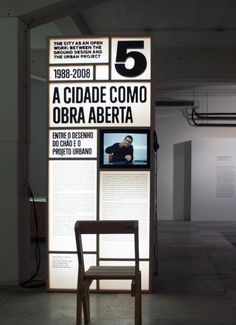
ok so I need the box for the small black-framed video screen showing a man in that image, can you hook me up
[100,129,150,168]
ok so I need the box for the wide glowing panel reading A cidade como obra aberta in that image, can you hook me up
[49,82,151,127]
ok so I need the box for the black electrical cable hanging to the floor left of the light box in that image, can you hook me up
[20,186,46,288]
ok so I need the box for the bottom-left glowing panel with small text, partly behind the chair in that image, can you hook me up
[49,254,96,290]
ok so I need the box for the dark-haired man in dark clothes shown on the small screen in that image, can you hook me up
[105,135,134,164]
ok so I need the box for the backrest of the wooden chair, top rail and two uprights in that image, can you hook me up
[75,220,139,276]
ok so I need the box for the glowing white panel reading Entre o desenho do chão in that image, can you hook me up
[49,129,97,159]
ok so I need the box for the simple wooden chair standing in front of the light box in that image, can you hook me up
[75,220,142,325]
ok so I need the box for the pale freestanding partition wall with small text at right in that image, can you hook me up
[189,138,236,221]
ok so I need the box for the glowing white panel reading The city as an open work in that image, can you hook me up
[49,37,109,64]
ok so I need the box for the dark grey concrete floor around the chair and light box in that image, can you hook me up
[0,221,236,325]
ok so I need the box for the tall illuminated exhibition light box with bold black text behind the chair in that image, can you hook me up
[48,36,155,291]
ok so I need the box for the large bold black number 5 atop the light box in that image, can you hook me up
[115,41,147,77]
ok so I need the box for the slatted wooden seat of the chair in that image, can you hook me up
[84,266,135,280]
